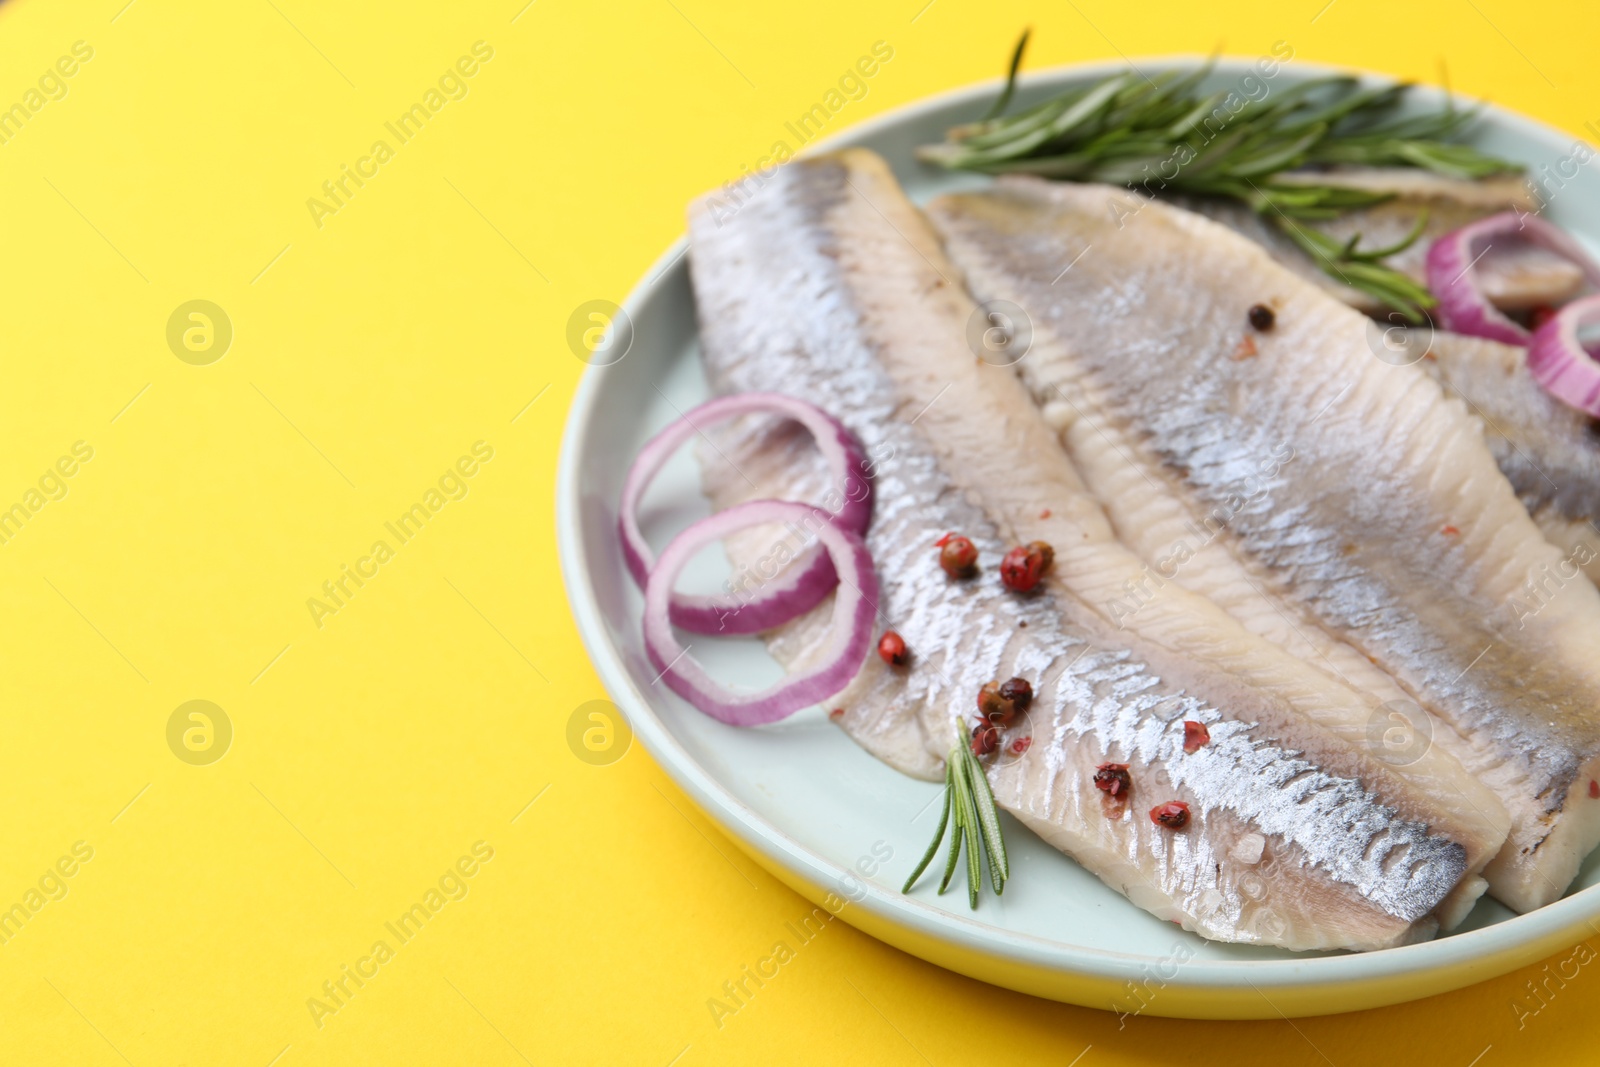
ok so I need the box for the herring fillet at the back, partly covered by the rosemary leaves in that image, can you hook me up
[1163,168,1584,315]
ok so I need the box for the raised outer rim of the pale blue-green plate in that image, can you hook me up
[555,53,1600,1019]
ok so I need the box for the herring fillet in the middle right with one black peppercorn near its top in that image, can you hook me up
[928,178,1600,910]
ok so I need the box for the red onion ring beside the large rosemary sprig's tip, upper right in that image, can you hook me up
[1427,211,1600,346]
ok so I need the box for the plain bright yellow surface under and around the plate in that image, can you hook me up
[0,0,1600,1067]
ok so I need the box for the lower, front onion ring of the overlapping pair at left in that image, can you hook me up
[645,501,878,726]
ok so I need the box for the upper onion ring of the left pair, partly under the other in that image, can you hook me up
[618,392,872,633]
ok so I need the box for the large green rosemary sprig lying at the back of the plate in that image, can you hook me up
[917,34,1522,320]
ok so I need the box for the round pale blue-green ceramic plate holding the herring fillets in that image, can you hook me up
[557,58,1600,1019]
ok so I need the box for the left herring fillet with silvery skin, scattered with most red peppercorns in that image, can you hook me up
[690,152,1496,949]
